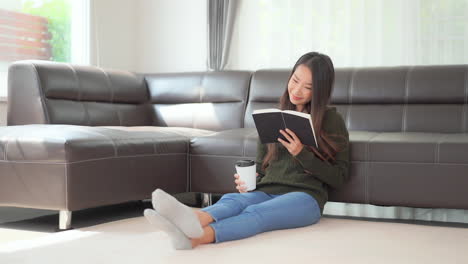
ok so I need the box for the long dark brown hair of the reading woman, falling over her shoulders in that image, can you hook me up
[262,52,339,170]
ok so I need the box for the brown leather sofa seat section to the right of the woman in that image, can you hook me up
[348,131,468,208]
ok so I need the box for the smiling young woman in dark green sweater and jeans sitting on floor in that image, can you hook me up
[144,52,349,249]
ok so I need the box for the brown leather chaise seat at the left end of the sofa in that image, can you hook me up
[0,125,212,211]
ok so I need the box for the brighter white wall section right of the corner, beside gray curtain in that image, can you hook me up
[135,0,207,72]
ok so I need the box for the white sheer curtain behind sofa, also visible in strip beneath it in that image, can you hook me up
[226,0,468,223]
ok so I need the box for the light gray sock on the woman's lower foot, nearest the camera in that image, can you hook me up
[143,209,192,249]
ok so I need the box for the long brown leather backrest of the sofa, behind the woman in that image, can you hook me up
[8,61,468,133]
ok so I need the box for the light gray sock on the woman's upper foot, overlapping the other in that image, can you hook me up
[152,189,203,238]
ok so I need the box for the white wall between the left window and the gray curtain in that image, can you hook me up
[90,0,207,72]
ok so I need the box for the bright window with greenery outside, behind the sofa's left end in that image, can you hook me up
[0,0,89,99]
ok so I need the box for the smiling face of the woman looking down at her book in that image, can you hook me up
[288,64,312,112]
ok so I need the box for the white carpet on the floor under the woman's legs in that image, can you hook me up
[0,217,468,264]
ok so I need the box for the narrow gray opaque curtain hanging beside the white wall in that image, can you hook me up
[208,0,237,71]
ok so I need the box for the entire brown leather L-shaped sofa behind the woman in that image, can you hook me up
[0,61,468,229]
